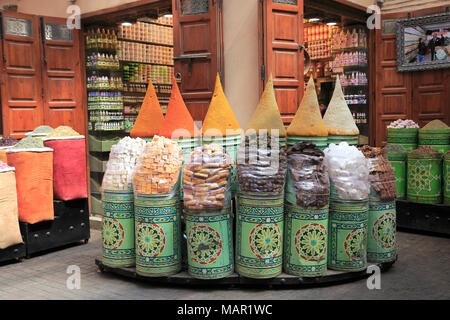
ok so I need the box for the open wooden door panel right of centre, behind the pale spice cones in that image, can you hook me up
[259,0,304,124]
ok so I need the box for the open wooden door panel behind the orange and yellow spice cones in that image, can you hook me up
[172,0,224,121]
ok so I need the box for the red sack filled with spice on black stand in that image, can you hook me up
[42,136,87,201]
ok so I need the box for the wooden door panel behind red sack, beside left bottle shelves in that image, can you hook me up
[40,17,86,134]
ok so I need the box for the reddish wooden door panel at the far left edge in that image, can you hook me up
[1,11,43,138]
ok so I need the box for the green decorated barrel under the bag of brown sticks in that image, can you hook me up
[185,205,234,279]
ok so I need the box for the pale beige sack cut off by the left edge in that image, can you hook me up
[0,162,22,249]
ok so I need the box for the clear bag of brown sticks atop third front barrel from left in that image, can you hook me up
[183,144,233,211]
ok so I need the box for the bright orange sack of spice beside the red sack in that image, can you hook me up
[6,145,54,224]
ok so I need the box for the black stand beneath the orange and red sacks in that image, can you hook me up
[20,198,90,258]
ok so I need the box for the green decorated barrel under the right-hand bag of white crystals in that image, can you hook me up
[327,198,369,272]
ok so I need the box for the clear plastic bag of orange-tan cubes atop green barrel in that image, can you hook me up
[133,136,183,194]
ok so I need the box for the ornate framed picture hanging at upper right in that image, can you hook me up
[397,13,450,72]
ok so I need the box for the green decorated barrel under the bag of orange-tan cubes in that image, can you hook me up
[134,192,181,277]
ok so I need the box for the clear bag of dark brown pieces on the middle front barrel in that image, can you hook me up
[237,135,287,194]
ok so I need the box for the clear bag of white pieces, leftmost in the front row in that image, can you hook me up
[102,137,146,191]
